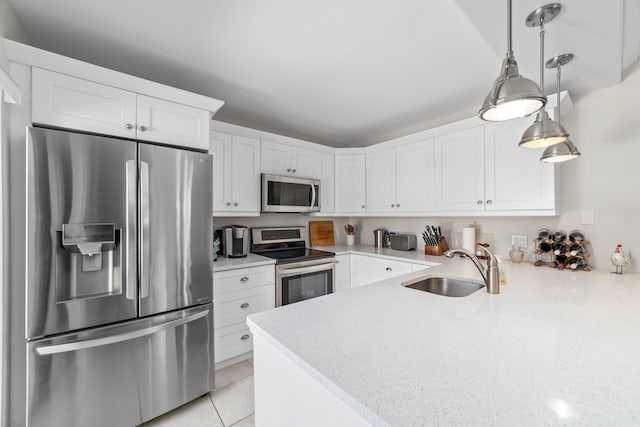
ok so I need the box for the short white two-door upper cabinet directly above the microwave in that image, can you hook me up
[261,140,322,179]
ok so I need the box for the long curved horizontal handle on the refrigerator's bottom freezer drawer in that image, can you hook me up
[36,309,209,356]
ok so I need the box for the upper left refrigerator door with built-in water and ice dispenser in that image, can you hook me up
[26,128,138,339]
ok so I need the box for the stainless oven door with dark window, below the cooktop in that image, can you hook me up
[276,258,336,307]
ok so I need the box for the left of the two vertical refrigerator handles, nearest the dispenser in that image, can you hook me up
[124,160,138,300]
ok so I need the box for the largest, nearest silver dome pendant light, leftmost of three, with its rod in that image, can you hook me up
[478,0,547,122]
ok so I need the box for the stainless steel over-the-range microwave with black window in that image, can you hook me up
[262,173,320,212]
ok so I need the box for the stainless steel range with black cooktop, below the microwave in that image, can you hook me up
[251,227,336,307]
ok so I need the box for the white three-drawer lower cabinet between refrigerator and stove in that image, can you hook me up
[213,265,275,364]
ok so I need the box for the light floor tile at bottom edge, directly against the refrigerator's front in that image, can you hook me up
[144,396,224,427]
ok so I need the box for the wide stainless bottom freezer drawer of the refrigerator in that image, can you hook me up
[27,304,214,427]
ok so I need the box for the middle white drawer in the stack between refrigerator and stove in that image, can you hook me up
[214,285,275,328]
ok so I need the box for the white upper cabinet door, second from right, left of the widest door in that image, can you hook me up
[435,126,484,211]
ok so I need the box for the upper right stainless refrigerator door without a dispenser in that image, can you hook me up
[139,144,213,316]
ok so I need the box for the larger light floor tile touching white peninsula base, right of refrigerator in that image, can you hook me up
[209,375,254,426]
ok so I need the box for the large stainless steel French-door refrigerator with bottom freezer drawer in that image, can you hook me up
[25,127,213,427]
